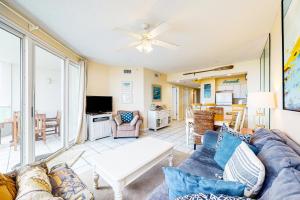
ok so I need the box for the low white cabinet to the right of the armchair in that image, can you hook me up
[148,110,171,131]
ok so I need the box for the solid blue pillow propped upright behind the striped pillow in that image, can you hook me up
[214,132,242,169]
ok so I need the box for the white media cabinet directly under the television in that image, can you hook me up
[87,114,112,141]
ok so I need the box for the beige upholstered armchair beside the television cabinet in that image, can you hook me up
[111,110,143,139]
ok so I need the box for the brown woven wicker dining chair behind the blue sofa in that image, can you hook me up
[193,110,215,150]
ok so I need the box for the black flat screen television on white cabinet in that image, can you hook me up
[86,96,112,114]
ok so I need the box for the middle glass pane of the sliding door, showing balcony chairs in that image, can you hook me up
[34,46,64,157]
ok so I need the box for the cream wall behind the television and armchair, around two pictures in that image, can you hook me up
[87,62,191,128]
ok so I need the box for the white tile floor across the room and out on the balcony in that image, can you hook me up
[0,122,193,174]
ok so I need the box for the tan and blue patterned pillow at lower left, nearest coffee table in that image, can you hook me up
[49,163,94,200]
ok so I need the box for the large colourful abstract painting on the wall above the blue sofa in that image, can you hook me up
[281,0,300,112]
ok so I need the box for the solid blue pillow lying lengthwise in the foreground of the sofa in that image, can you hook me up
[163,167,245,200]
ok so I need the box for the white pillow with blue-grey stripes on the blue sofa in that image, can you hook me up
[223,142,265,197]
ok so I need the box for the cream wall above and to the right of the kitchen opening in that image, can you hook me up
[167,59,260,128]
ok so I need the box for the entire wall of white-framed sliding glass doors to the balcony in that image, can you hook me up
[0,19,82,169]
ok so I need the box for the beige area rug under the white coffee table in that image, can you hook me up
[79,151,189,200]
